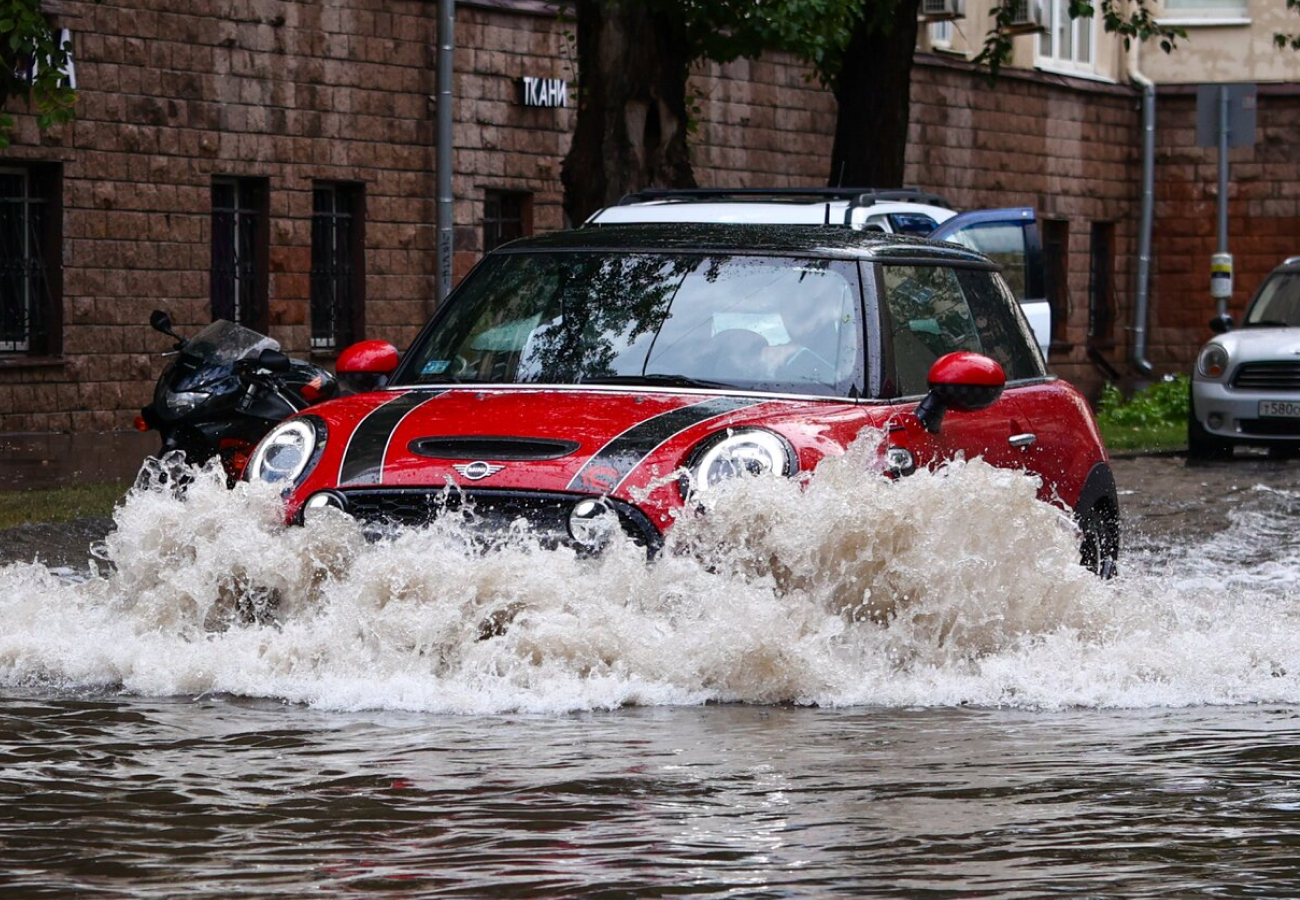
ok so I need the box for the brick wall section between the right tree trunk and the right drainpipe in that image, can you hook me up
[906,55,1140,395]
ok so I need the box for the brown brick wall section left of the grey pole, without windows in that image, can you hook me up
[0,0,433,430]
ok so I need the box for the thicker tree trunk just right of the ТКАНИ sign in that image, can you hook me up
[560,0,696,225]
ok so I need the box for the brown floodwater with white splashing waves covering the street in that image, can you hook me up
[0,453,1300,897]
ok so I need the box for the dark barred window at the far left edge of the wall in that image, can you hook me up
[0,166,62,355]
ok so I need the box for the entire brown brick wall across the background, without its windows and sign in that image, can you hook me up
[0,0,1300,432]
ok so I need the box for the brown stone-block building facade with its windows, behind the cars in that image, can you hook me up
[0,0,1300,432]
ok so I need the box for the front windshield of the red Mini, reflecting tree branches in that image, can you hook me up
[398,251,863,397]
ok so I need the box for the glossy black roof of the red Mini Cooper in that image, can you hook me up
[493,222,997,269]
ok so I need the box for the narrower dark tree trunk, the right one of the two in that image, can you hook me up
[828,0,920,187]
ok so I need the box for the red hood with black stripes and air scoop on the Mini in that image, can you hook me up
[311,388,810,494]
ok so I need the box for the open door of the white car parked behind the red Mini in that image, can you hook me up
[930,207,1052,359]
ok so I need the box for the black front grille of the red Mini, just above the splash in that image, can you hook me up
[337,488,663,553]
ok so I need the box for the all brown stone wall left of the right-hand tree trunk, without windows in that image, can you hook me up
[0,0,833,432]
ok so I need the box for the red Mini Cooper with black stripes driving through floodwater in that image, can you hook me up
[247,225,1119,575]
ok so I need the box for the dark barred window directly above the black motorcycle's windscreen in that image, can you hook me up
[208,178,269,332]
